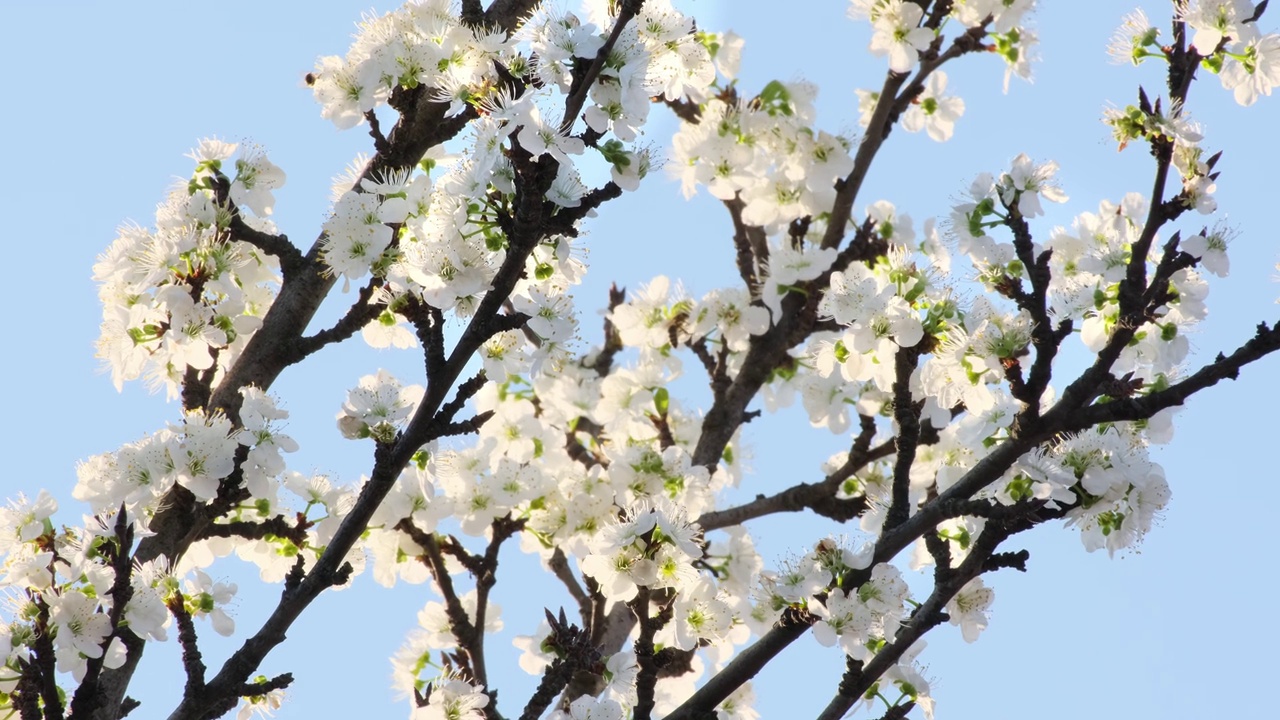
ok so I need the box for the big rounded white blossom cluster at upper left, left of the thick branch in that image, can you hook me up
[93,140,284,398]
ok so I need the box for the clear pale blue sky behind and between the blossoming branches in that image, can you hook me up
[0,0,1280,720]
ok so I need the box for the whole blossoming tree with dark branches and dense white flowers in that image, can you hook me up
[0,0,1280,719]
